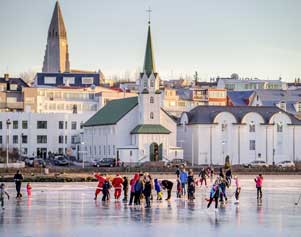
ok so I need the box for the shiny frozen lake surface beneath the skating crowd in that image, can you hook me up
[0,176,301,237]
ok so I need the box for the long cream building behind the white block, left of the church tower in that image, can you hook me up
[23,86,136,116]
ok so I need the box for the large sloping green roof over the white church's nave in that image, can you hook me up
[84,97,138,127]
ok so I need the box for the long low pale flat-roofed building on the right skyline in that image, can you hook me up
[217,77,287,91]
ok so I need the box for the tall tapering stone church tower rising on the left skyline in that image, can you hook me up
[42,1,70,72]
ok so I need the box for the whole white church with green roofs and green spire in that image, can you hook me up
[84,22,183,163]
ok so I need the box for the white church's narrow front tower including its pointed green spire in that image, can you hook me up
[139,21,161,124]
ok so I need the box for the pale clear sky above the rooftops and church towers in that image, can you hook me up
[0,0,301,81]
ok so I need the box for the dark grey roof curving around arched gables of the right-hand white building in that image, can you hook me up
[182,106,301,125]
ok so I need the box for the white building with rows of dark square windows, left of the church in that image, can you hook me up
[0,112,89,158]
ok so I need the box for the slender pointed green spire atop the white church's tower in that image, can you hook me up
[143,25,156,75]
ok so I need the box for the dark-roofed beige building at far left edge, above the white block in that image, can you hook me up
[0,74,28,112]
